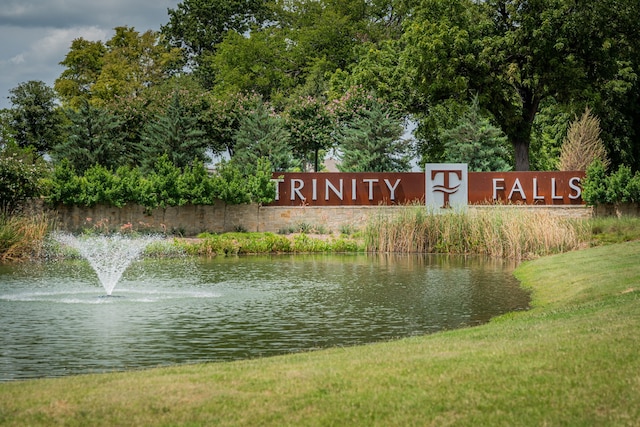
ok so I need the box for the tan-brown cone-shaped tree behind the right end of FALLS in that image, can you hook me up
[558,108,610,171]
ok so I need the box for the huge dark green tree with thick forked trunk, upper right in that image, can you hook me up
[405,0,639,170]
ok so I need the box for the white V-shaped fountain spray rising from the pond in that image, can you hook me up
[54,233,159,296]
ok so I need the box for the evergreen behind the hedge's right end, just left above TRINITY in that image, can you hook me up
[233,103,294,172]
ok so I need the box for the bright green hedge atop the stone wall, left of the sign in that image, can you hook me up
[47,155,275,209]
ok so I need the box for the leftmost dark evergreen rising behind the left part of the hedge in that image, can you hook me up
[51,99,142,173]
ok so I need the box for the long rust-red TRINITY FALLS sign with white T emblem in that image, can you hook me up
[271,164,584,207]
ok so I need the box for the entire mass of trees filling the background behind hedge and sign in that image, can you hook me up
[1,0,640,200]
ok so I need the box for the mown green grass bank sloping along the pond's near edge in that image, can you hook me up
[0,242,640,426]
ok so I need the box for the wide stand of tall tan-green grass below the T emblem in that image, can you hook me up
[364,206,590,260]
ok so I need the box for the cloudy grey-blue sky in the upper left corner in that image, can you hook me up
[0,0,181,109]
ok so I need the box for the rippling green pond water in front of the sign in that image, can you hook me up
[0,254,529,381]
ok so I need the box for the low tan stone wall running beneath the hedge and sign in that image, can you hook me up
[47,201,592,236]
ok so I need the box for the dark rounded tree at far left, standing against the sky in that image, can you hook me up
[9,80,63,155]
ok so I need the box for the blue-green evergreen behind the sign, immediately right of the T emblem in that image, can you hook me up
[441,97,511,172]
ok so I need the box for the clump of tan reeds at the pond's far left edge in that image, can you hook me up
[0,213,51,261]
